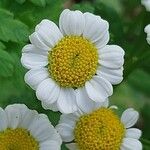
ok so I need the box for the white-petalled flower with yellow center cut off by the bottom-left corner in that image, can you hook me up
[0,104,62,150]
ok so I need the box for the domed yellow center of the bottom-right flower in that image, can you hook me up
[74,108,125,150]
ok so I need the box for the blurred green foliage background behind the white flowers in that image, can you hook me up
[0,0,150,150]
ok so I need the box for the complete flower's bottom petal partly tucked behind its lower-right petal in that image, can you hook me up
[76,88,106,113]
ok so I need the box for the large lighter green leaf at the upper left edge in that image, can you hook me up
[0,9,29,43]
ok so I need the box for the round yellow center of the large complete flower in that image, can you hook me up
[48,36,98,88]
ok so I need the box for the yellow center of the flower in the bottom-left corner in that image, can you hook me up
[0,128,39,150]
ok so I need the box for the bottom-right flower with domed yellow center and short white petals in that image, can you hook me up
[56,103,142,150]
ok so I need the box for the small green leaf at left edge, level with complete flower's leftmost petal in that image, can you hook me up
[0,49,14,77]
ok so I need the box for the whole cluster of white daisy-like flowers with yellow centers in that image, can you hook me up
[0,2,150,150]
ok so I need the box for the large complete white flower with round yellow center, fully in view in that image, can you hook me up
[21,9,124,113]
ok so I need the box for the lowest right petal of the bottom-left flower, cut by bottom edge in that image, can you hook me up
[40,140,61,150]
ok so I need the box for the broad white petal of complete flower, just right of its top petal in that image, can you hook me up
[83,13,109,44]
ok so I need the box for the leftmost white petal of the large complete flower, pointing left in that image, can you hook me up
[21,44,48,69]
